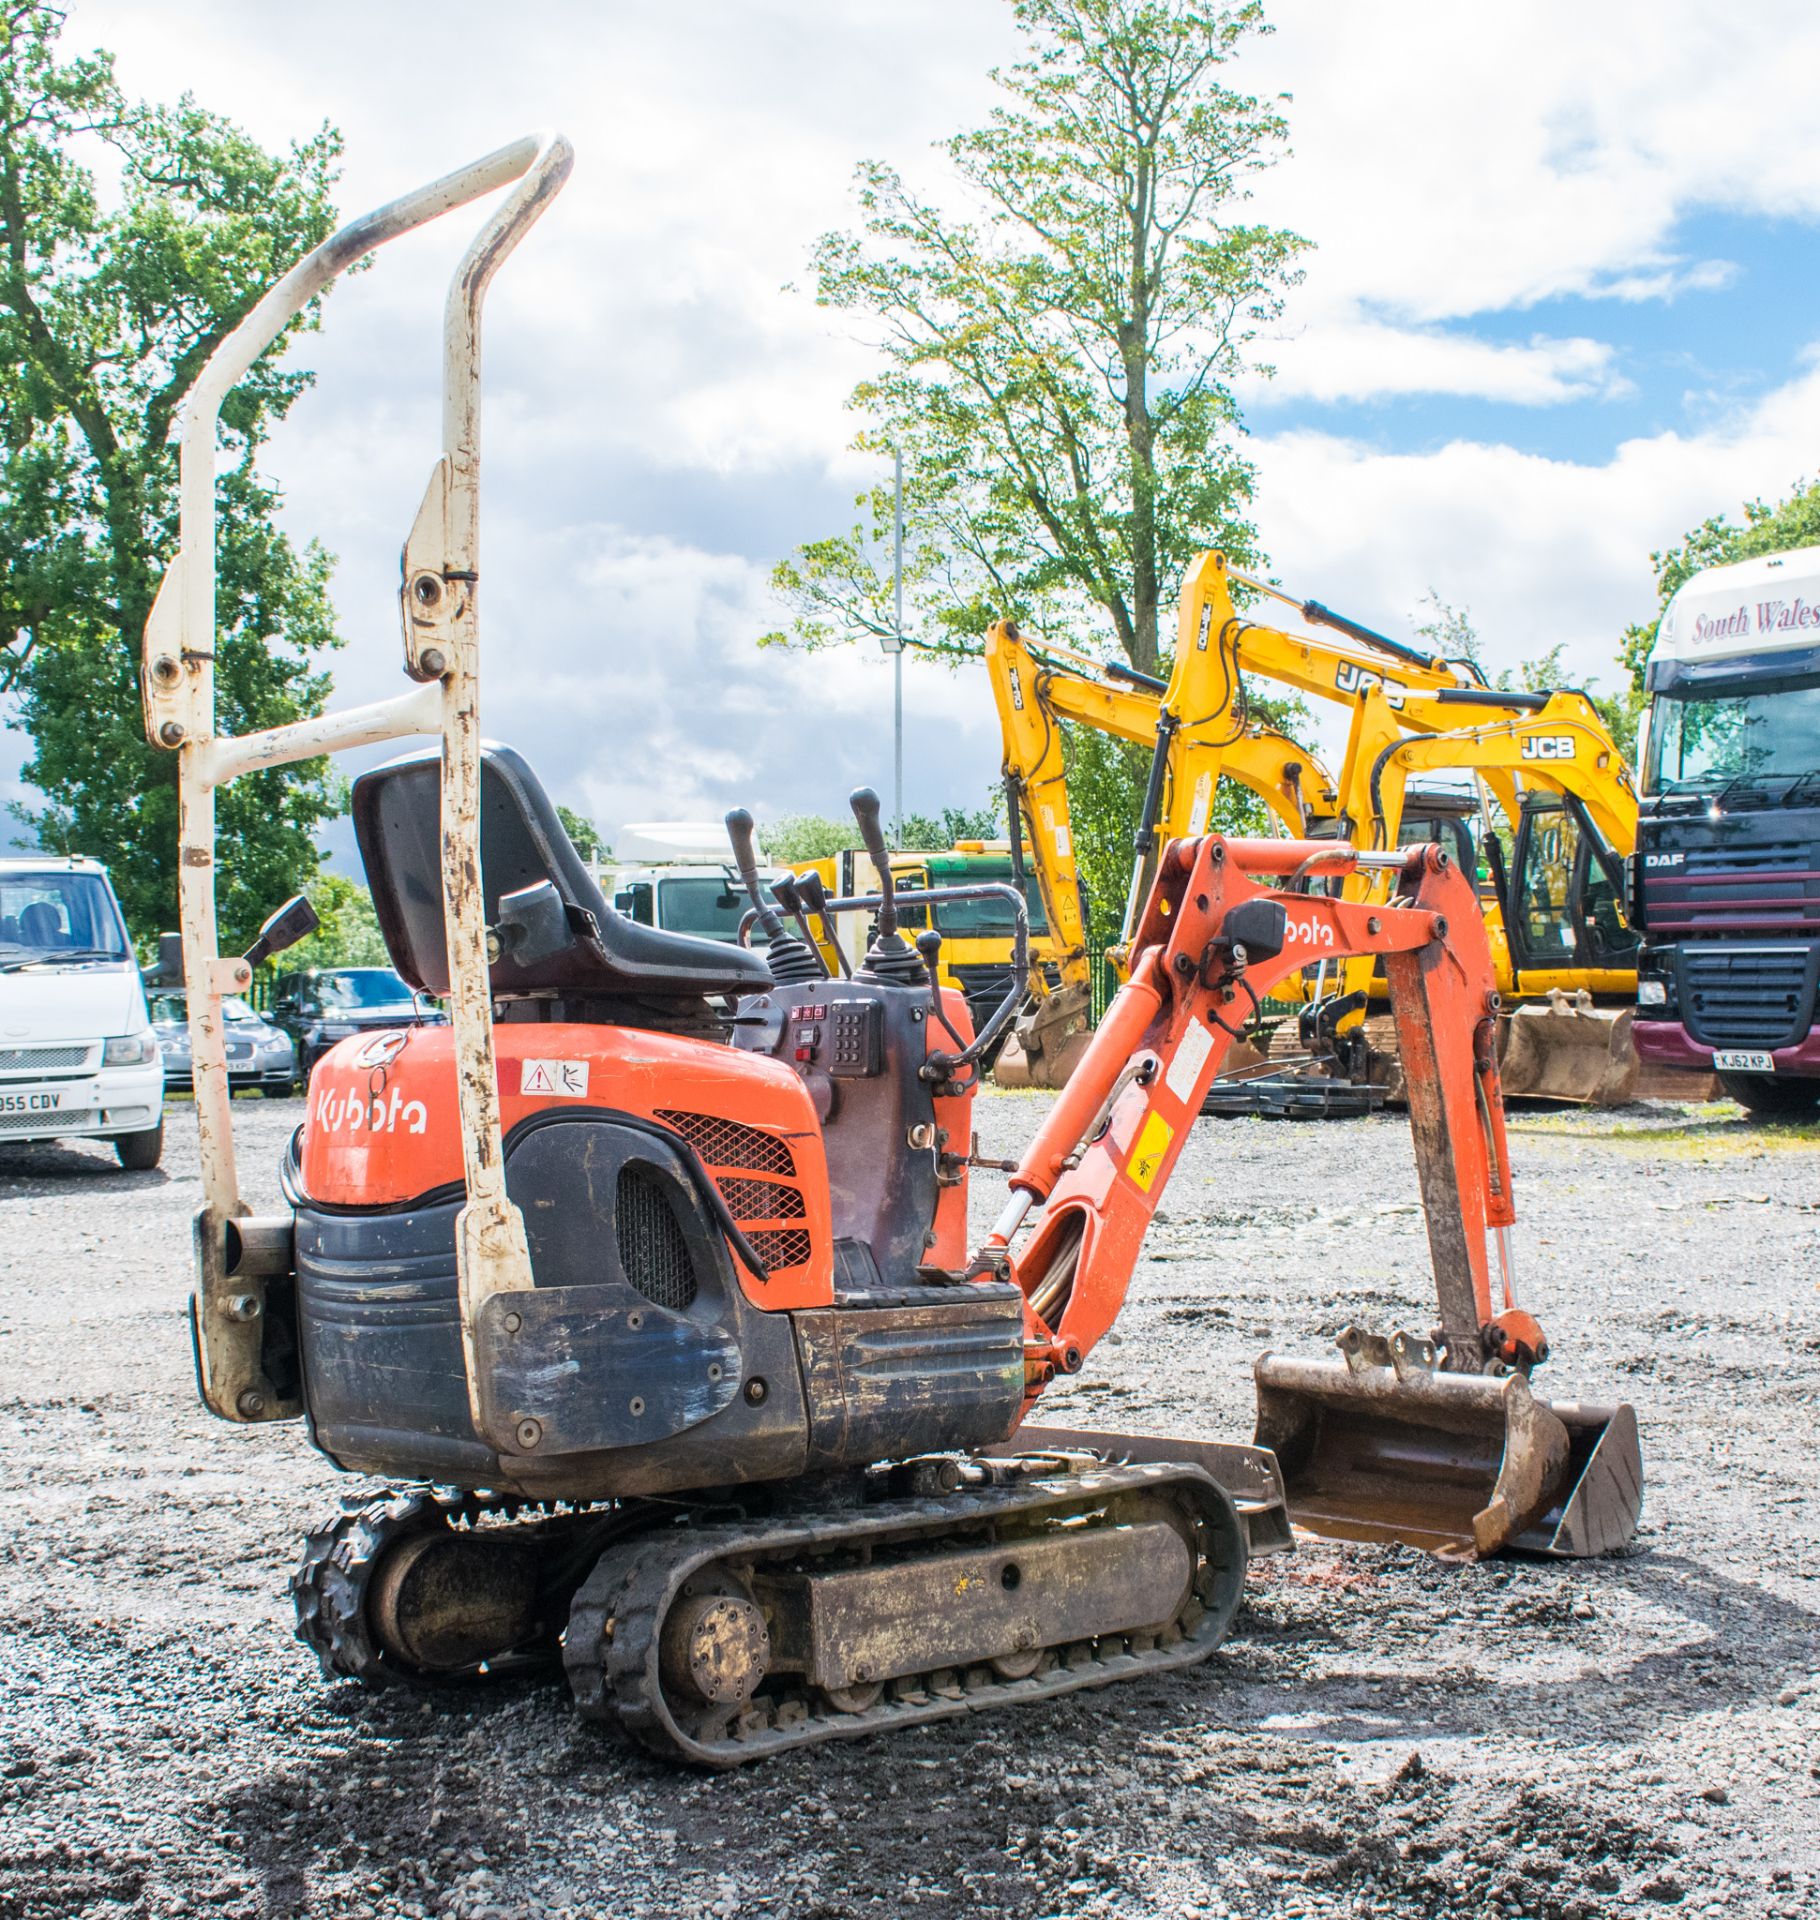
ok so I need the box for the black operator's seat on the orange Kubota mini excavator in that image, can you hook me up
[353,743,772,998]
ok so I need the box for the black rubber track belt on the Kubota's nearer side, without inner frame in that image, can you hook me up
[563,1465,1246,1768]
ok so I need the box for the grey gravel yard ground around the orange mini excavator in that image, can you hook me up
[0,1094,1820,1920]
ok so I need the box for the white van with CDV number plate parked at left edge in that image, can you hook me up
[0,854,165,1173]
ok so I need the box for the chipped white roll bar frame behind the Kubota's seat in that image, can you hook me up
[142,132,574,1421]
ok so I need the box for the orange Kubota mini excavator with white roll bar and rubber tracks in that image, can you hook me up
[144,136,1636,1766]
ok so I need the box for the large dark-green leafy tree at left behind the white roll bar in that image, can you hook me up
[0,0,344,947]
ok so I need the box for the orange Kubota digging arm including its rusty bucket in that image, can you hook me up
[987,837,1641,1555]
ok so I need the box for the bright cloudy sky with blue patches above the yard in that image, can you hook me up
[0,0,1820,864]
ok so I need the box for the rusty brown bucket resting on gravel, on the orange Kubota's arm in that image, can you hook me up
[1254,1329,1643,1559]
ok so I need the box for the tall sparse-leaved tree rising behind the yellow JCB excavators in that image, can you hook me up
[768,0,1304,672]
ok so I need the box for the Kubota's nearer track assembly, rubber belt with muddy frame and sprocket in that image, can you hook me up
[563,1455,1246,1768]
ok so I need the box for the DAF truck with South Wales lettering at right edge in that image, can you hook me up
[1632,547,1820,1114]
